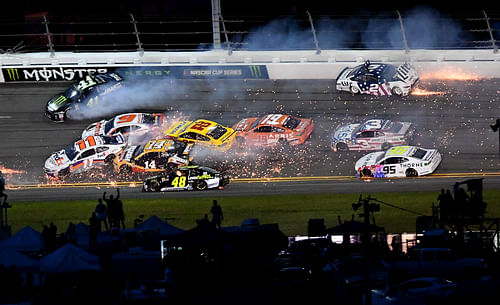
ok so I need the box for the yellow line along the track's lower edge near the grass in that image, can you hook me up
[6,172,500,190]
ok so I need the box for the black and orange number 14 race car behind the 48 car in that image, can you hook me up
[113,139,194,173]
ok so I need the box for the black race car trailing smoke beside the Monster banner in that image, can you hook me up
[45,72,123,122]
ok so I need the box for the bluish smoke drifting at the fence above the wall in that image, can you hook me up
[236,7,468,50]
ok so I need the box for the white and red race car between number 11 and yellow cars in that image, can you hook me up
[82,113,165,139]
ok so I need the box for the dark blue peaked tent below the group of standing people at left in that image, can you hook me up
[40,243,101,273]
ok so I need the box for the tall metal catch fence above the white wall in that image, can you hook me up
[0,11,500,53]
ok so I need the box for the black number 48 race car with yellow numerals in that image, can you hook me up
[142,165,229,192]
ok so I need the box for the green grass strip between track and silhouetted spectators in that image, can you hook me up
[8,190,500,236]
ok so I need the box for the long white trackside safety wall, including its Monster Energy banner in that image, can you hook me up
[0,49,500,82]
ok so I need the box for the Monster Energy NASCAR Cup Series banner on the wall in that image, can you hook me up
[0,65,269,82]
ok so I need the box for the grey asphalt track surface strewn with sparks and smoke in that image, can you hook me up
[0,79,500,201]
